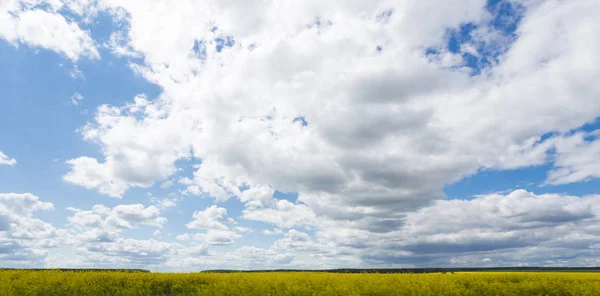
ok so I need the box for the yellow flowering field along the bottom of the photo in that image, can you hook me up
[0,271,600,296]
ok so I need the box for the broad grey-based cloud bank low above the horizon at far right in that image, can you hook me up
[356,190,600,266]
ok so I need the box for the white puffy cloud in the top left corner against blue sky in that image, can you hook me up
[0,0,100,61]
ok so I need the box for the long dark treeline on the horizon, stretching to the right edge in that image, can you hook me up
[202,267,600,273]
